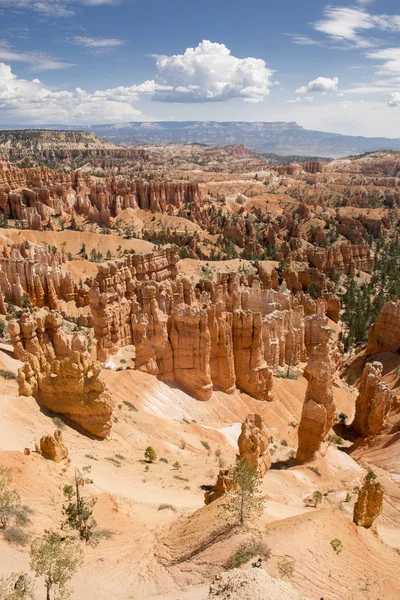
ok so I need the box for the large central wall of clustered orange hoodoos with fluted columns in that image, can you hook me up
[88,247,334,400]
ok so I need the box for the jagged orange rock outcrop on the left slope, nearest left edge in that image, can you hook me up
[9,309,114,438]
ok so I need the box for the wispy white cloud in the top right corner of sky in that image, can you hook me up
[313,6,400,48]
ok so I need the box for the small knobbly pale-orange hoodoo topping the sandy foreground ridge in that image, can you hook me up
[238,414,272,477]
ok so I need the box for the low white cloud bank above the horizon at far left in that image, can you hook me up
[0,63,146,124]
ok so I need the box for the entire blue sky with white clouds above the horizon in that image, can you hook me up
[0,0,400,137]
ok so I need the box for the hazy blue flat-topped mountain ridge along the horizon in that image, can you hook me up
[0,121,400,158]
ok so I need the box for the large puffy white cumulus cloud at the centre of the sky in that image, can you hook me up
[153,40,274,102]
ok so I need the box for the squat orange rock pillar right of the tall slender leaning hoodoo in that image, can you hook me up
[352,361,393,437]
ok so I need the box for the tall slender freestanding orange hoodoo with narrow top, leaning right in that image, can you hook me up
[296,327,337,464]
